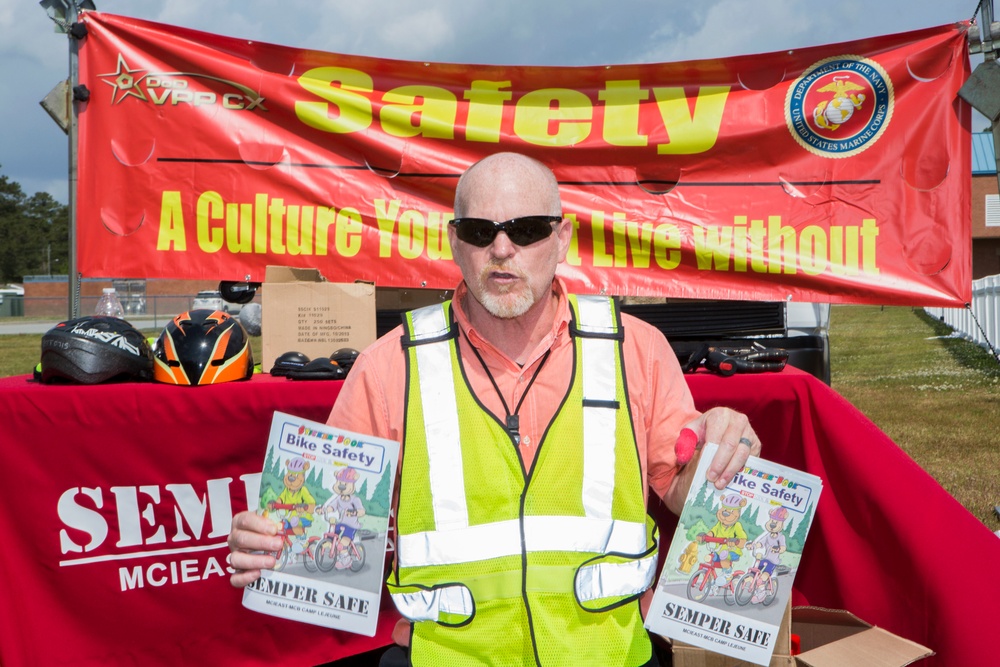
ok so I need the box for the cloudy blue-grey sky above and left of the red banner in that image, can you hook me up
[0,0,993,204]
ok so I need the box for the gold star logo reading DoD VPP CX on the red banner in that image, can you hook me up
[97,53,267,111]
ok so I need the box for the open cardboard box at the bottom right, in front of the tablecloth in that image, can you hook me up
[673,607,934,667]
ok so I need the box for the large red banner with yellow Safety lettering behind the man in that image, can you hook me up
[77,12,971,305]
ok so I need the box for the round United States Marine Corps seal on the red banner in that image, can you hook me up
[785,55,893,158]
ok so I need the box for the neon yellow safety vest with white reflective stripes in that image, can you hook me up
[387,295,656,667]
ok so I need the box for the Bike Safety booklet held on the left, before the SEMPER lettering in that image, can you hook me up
[243,412,399,637]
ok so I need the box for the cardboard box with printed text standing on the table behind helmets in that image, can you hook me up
[259,266,375,373]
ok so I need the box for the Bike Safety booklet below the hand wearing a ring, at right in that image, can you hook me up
[645,443,822,665]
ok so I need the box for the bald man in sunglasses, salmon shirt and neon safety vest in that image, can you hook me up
[229,153,760,667]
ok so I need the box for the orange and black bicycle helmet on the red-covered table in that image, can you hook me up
[153,308,253,385]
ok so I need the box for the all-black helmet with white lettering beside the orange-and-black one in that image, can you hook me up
[40,316,153,384]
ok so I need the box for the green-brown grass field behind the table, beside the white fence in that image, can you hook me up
[0,306,1000,531]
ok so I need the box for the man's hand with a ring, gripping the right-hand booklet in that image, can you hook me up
[663,407,760,514]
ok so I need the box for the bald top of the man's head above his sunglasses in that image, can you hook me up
[455,153,562,220]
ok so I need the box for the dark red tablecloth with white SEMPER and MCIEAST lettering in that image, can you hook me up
[0,369,1000,667]
